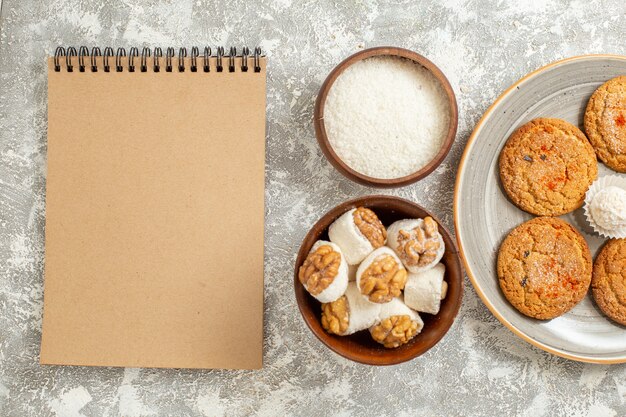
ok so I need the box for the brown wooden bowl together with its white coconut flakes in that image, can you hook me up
[314,47,458,188]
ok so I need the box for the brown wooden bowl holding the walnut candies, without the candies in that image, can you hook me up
[293,195,463,365]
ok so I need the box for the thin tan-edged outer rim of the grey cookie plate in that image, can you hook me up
[453,54,626,364]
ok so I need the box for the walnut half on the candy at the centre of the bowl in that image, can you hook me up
[359,255,407,303]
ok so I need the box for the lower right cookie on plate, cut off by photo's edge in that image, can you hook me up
[591,239,626,326]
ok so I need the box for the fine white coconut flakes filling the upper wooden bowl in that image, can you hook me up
[323,56,450,179]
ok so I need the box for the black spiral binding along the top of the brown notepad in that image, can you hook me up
[53,46,263,72]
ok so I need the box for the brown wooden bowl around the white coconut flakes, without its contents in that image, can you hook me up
[313,46,459,188]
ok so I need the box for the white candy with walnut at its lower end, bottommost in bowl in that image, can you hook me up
[370,298,424,348]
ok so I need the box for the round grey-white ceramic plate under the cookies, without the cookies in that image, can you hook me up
[454,55,626,363]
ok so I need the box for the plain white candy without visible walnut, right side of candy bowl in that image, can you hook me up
[404,263,448,314]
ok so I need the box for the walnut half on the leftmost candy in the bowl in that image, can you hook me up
[298,245,341,295]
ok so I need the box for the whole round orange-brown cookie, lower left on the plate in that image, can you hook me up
[498,217,592,320]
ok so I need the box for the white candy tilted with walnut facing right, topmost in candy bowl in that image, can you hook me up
[328,207,387,265]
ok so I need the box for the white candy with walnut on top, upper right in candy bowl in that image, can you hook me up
[387,216,446,273]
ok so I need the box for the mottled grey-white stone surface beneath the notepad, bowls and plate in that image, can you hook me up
[0,0,626,417]
